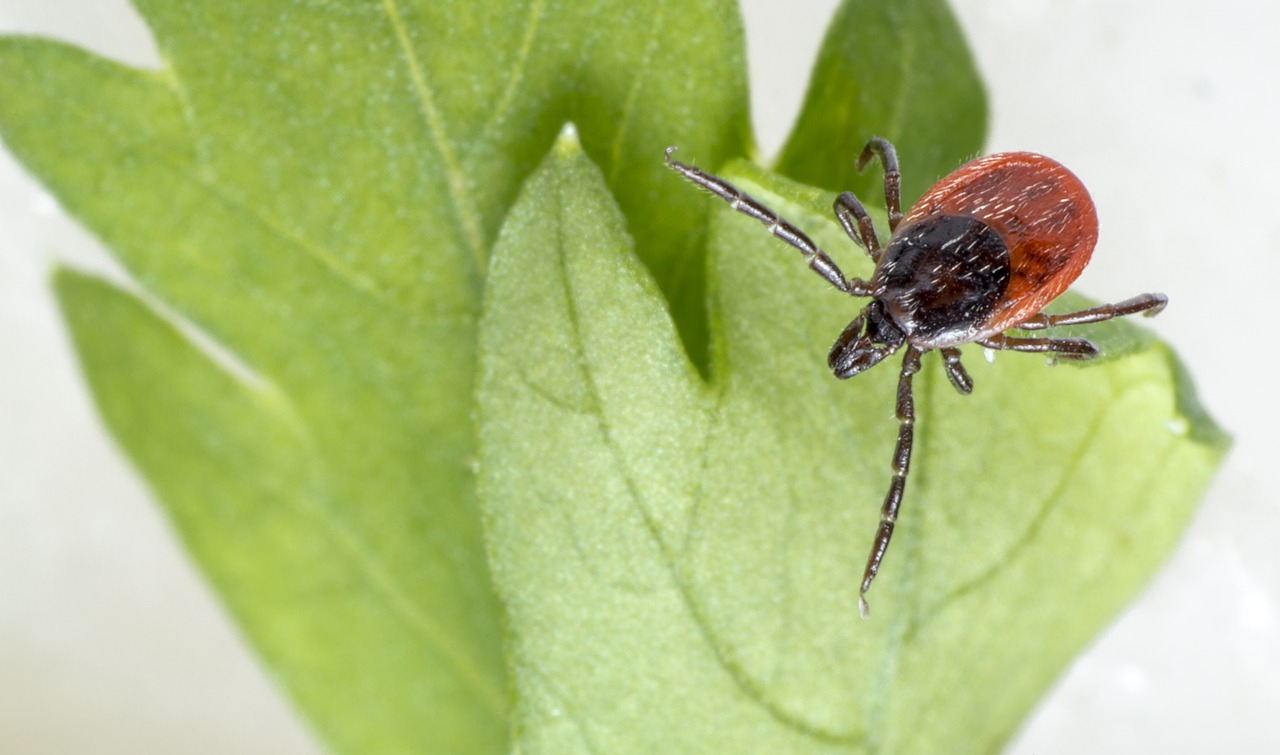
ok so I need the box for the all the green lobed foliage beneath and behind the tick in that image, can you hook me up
[0,0,1225,754]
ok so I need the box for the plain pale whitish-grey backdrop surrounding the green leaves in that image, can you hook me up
[0,0,1280,755]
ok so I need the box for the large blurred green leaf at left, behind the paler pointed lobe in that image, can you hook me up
[0,0,749,752]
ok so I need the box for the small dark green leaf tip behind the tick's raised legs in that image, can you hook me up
[777,0,987,209]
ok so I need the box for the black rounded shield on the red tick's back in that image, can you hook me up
[872,215,1011,348]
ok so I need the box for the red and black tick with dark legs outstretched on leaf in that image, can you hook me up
[667,137,1169,618]
